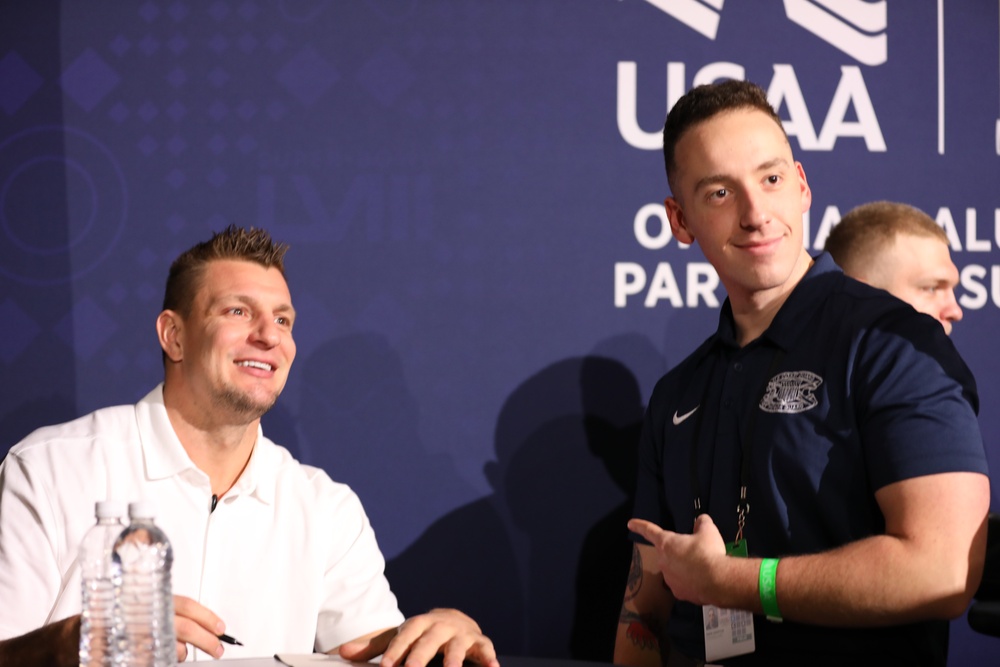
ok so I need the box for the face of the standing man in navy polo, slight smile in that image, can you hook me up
[665,108,812,308]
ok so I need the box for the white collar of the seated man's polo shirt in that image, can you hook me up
[135,382,280,504]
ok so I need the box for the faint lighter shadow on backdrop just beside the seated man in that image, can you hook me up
[294,333,476,560]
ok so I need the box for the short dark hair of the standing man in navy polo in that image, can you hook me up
[663,79,788,191]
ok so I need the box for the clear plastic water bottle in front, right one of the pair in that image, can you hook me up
[112,501,177,667]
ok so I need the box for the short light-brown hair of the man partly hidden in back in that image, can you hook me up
[823,201,948,275]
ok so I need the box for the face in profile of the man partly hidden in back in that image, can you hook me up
[859,233,962,334]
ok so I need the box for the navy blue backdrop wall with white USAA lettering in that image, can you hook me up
[0,0,1000,664]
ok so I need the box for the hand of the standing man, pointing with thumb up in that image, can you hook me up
[628,514,730,605]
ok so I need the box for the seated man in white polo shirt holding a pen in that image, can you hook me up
[0,226,498,667]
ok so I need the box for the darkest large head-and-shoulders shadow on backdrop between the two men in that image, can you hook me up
[387,348,656,661]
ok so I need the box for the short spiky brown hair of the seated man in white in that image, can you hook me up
[163,225,288,317]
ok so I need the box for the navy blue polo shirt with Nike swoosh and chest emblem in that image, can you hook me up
[635,253,987,665]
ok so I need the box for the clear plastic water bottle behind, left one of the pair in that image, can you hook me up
[78,500,125,667]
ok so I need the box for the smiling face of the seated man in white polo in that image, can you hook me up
[157,260,295,423]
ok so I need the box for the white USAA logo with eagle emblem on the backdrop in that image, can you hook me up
[617,0,888,153]
